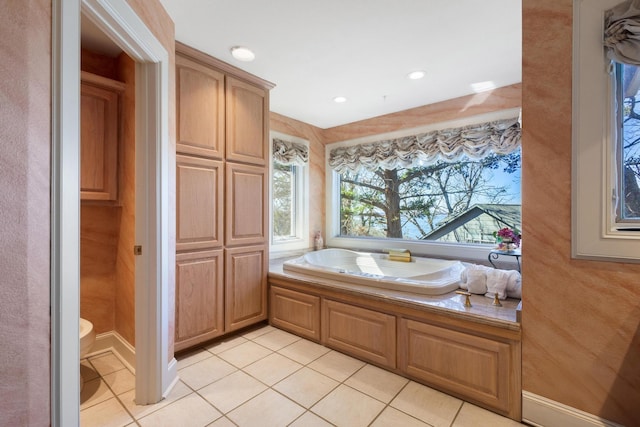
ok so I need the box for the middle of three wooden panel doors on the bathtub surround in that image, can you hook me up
[322,300,396,369]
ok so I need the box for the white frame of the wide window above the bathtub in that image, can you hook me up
[325,108,520,266]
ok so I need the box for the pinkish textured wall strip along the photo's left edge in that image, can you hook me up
[0,0,51,426]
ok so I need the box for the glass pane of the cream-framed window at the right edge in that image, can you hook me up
[615,63,640,228]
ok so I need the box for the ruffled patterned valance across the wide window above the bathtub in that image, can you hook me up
[329,117,521,173]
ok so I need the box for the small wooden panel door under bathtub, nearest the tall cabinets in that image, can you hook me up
[269,286,320,341]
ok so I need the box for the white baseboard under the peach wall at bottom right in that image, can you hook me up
[522,390,623,427]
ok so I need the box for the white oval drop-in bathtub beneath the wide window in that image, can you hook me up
[283,249,464,295]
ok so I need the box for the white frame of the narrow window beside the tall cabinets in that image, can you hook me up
[269,131,310,253]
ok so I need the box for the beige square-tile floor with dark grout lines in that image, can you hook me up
[80,326,521,427]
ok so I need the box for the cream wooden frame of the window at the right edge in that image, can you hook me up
[571,0,640,262]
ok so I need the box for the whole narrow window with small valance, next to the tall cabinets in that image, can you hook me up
[270,132,309,252]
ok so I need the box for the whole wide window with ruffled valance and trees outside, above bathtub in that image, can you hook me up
[327,110,522,259]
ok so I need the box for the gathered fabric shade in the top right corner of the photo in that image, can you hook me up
[604,0,640,65]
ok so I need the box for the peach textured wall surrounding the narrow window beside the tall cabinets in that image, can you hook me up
[270,112,326,246]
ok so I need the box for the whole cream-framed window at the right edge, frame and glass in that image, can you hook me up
[571,0,640,262]
